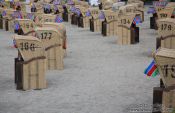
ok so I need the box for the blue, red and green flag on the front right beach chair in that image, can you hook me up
[144,60,159,77]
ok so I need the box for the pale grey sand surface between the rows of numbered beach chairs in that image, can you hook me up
[0,6,159,113]
